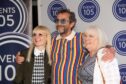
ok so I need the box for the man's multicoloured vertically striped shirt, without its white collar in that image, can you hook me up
[51,33,84,84]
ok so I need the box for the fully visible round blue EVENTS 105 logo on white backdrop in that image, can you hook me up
[78,0,100,22]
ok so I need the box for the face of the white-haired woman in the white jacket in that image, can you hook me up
[84,29,99,52]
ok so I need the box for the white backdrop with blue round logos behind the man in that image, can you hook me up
[38,0,126,84]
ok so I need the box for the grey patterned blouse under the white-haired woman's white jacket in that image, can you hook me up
[78,55,96,84]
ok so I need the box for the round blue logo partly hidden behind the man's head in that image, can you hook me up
[47,0,66,22]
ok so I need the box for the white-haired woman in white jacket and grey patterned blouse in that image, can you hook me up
[78,25,120,84]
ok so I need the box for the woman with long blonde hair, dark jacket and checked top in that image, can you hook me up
[14,26,51,84]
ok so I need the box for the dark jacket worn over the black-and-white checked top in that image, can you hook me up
[13,49,51,84]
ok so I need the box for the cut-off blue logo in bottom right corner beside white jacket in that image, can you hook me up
[119,64,126,84]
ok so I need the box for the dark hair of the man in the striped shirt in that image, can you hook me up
[57,9,77,29]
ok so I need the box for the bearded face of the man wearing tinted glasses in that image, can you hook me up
[56,13,72,35]
